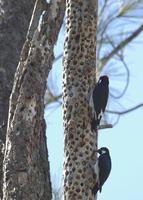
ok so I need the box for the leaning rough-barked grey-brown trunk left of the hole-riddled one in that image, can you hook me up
[3,0,65,200]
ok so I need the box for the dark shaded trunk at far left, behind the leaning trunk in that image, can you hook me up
[0,0,35,199]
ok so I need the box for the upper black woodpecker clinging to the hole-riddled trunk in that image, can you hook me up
[91,75,109,130]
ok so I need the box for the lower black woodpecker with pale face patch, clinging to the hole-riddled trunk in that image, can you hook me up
[93,147,111,195]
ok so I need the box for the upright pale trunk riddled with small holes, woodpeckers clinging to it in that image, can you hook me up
[63,0,97,200]
